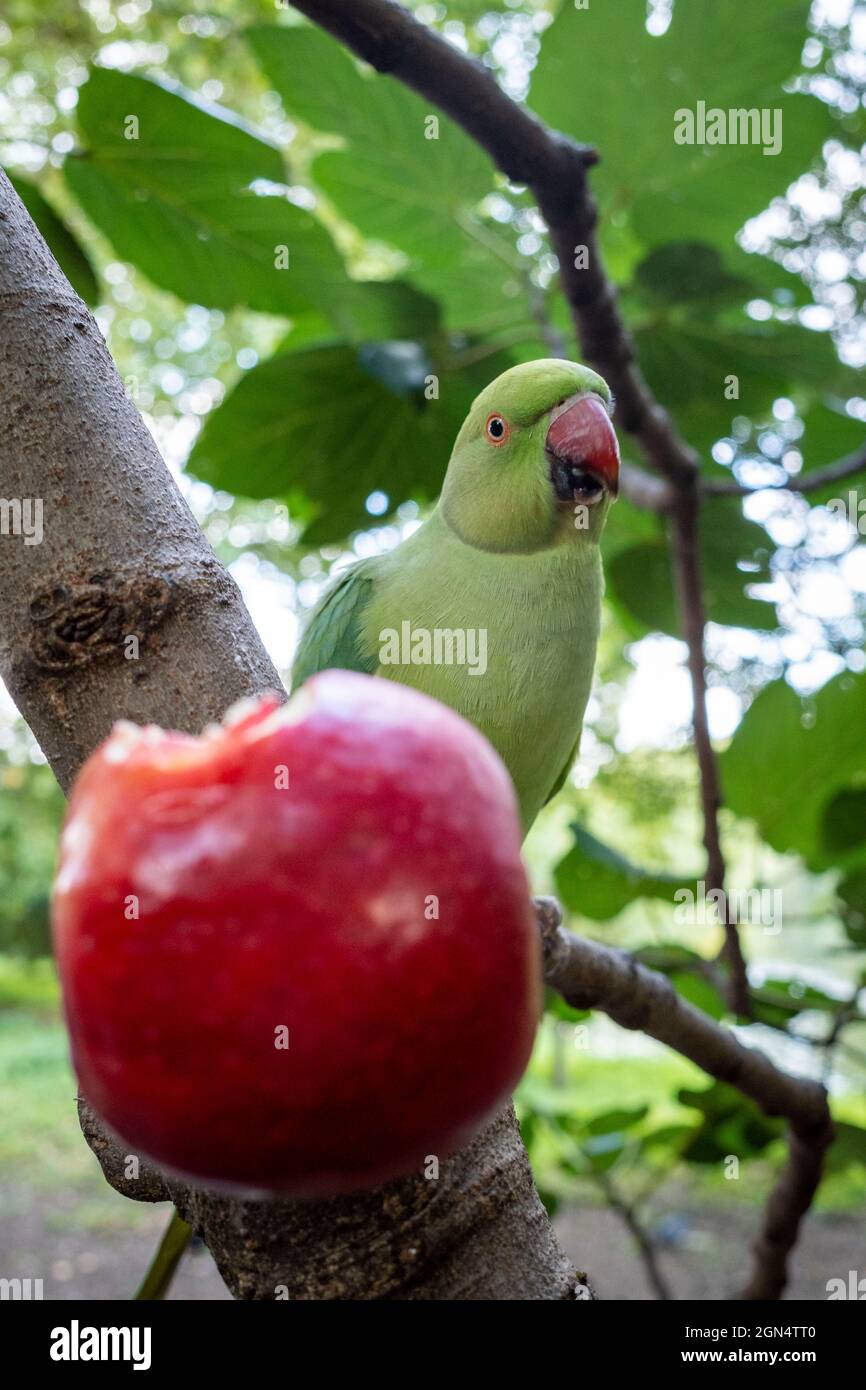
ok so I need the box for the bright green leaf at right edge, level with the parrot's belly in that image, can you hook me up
[721,673,866,867]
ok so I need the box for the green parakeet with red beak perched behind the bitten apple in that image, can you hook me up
[292,359,620,833]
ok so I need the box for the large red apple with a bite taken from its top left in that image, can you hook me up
[53,671,541,1197]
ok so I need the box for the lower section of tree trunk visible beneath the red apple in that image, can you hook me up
[79,1101,594,1302]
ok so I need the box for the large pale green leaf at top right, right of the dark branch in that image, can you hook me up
[530,0,833,246]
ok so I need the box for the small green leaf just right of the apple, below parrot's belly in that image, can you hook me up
[553,824,681,922]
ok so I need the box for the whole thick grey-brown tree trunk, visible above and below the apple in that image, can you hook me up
[0,172,591,1300]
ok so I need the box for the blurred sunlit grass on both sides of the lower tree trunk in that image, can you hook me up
[0,956,866,1229]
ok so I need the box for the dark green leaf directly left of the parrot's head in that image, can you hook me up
[189,343,509,545]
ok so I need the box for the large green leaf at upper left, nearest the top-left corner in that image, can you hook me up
[65,68,356,325]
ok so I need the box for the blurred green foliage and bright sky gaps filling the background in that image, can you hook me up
[0,0,866,1239]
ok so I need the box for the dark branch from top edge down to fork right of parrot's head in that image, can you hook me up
[292,0,698,478]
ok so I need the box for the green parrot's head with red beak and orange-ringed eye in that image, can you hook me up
[441,357,620,553]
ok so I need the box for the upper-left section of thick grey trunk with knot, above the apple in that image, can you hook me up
[0,189,279,791]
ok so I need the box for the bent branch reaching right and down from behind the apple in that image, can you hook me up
[537,898,833,1300]
